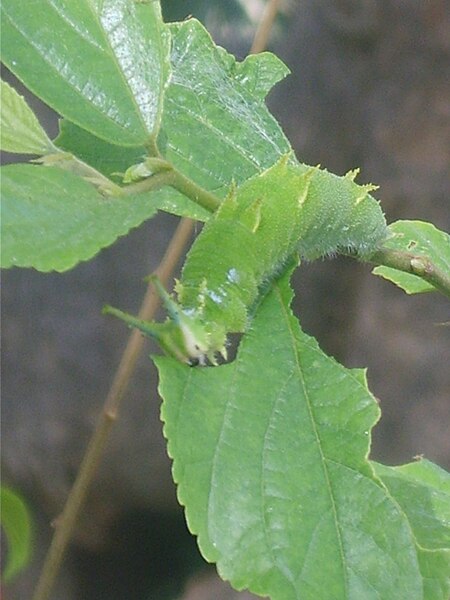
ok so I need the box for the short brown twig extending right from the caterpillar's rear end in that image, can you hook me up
[369,248,450,298]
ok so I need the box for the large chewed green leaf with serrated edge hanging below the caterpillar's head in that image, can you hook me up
[156,274,422,600]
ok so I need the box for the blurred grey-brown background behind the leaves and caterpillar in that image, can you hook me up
[2,0,450,600]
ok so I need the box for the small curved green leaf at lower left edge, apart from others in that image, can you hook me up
[0,485,31,583]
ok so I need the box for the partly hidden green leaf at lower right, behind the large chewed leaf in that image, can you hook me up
[373,459,450,600]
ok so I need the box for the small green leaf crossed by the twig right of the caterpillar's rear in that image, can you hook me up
[372,221,450,294]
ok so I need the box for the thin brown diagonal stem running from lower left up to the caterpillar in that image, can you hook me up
[33,219,194,600]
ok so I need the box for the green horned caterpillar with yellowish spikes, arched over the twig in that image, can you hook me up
[105,155,387,365]
